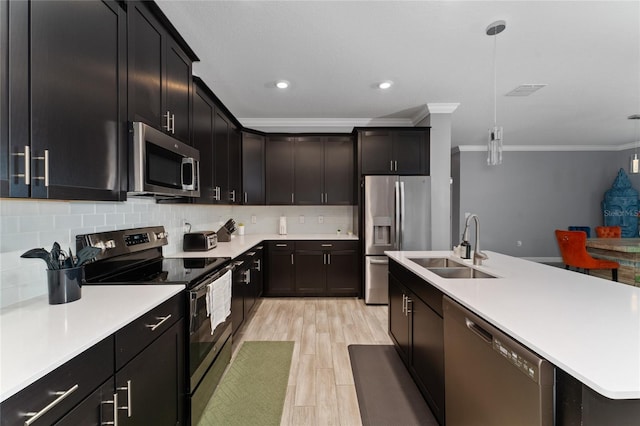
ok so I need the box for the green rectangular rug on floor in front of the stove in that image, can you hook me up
[198,342,294,426]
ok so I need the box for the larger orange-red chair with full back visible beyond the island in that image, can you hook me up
[556,229,620,281]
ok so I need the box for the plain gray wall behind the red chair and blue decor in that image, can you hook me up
[452,151,624,258]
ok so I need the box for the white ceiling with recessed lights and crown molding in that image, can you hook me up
[157,0,640,147]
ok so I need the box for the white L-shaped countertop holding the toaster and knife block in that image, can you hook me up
[172,234,358,258]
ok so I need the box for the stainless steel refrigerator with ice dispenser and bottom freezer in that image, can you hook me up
[362,176,431,304]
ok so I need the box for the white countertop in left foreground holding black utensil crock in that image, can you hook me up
[0,285,184,401]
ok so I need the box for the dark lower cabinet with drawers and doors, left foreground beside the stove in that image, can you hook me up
[0,294,186,426]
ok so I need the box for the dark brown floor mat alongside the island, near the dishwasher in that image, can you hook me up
[349,345,438,426]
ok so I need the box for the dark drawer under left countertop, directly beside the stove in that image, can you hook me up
[115,292,185,370]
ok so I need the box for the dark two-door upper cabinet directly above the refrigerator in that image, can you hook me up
[357,127,429,175]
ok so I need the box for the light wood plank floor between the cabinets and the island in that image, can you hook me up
[234,298,392,426]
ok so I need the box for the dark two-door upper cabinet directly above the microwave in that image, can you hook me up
[127,1,198,143]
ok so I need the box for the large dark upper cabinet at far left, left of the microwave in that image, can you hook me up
[0,1,127,201]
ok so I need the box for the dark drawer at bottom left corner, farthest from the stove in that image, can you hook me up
[0,336,114,426]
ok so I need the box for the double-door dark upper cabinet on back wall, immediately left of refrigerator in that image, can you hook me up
[294,136,354,205]
